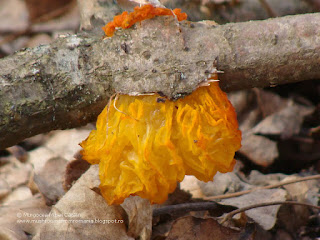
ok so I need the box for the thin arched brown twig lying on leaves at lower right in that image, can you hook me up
[220,201,320,224]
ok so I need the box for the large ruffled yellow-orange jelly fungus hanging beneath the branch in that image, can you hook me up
[81,82,241,205]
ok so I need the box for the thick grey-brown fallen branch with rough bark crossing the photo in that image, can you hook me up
[0,14,320,149]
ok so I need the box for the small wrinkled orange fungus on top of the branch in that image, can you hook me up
[102,4,187,37]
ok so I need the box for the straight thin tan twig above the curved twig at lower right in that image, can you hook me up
[204,174,320,200]
